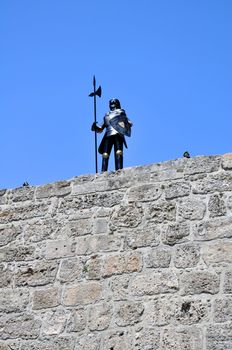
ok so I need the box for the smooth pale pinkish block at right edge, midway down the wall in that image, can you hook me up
[202,240,232,265]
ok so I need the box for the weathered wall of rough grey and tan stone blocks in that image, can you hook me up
[0,154,232,350]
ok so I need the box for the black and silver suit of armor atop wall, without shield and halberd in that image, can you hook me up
[92,99,132,172]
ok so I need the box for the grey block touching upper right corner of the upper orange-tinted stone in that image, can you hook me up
[125,225,160,249]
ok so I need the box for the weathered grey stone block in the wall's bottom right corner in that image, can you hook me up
[206,322,232,350]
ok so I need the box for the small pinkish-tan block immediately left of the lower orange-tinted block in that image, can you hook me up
[33,287,61,310]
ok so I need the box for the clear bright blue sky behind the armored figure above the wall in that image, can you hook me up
[0,0,232,188]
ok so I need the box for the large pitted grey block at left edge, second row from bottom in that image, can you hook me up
[0,314,41,339]
